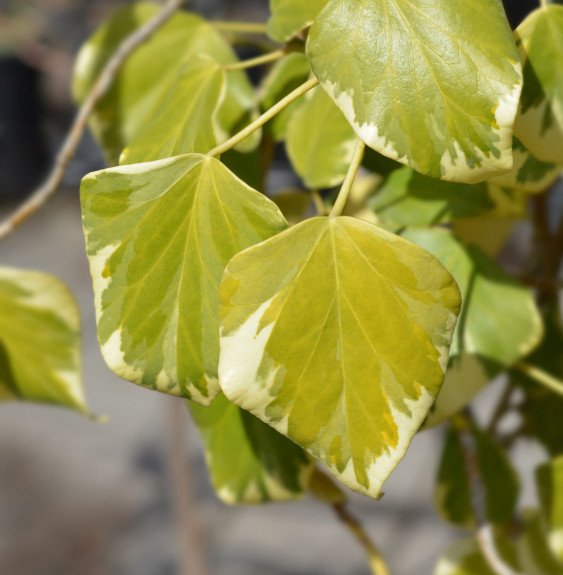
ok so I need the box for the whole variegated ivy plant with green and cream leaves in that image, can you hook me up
[0,0,563,575]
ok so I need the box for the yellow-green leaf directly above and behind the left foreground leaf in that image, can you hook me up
[120,56,225,164]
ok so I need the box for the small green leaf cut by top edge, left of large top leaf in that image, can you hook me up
[268,0,327,42]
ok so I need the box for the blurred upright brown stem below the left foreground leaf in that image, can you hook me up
[168,398,213,575]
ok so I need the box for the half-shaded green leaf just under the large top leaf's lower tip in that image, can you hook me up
[371,167,494,227]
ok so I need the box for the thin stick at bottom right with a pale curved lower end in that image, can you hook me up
[456,415,522,575]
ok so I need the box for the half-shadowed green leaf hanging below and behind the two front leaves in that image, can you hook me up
[190,394,312,504]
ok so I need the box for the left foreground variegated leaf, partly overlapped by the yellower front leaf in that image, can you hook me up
[81,154,287,404]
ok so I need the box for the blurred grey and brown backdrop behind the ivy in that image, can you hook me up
[0,0,552,575]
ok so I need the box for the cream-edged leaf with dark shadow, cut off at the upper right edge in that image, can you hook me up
[514,4,563,164]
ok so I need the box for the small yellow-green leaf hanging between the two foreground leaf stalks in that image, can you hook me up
[286,88,358,189]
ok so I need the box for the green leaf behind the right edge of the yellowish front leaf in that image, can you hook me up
[404,229,543,366]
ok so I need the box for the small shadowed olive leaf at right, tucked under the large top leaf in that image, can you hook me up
[490,138,563,193]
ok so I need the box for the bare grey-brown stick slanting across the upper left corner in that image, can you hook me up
[0,0,185,239]
